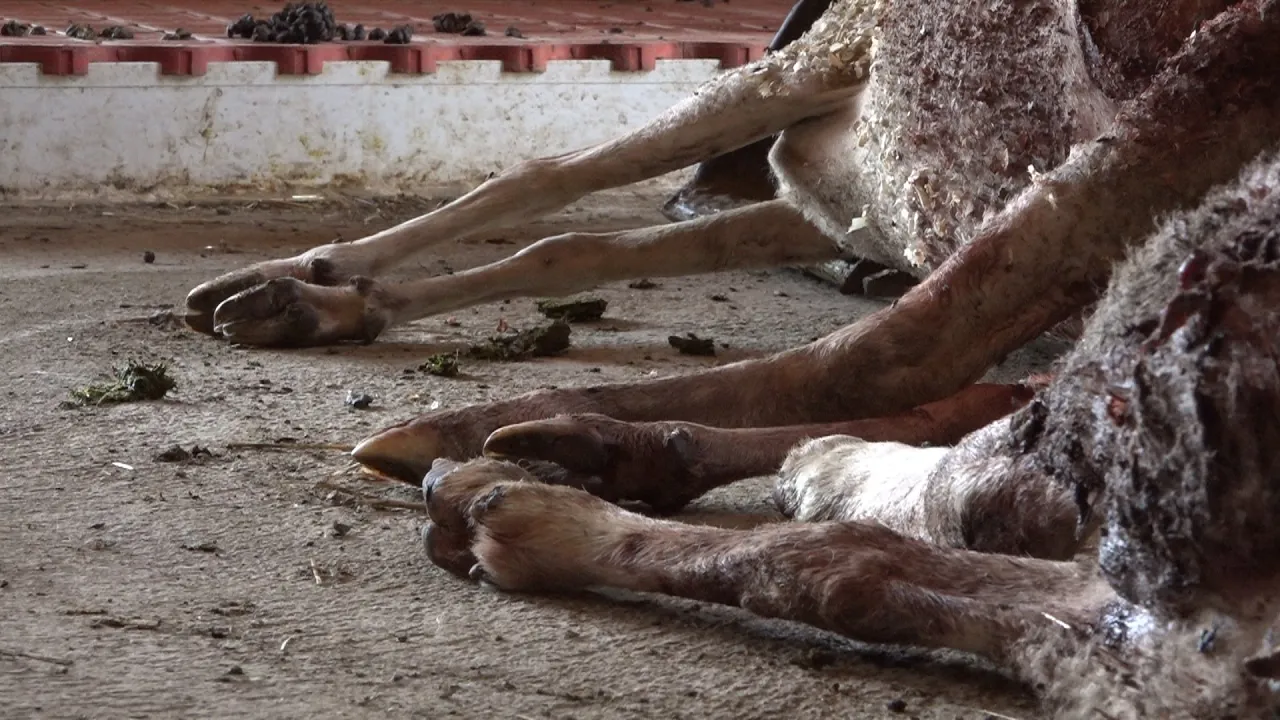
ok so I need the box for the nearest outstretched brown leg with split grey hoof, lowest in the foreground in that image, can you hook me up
[424,460,1110,661]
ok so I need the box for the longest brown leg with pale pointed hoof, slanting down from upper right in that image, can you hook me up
[355,0,1280,482]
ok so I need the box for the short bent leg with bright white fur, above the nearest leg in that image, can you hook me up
[773,419,1091,560]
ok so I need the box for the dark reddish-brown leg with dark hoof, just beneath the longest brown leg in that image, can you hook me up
[484,384,1032,514]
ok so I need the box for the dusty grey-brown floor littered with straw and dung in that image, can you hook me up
[0,185,1046,720]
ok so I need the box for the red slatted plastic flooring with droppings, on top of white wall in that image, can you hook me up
[0,0,792,74]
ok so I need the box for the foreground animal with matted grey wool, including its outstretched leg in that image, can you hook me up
[424,155,1280,717]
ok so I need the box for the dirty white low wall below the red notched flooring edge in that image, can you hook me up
[0,60,719,200]
